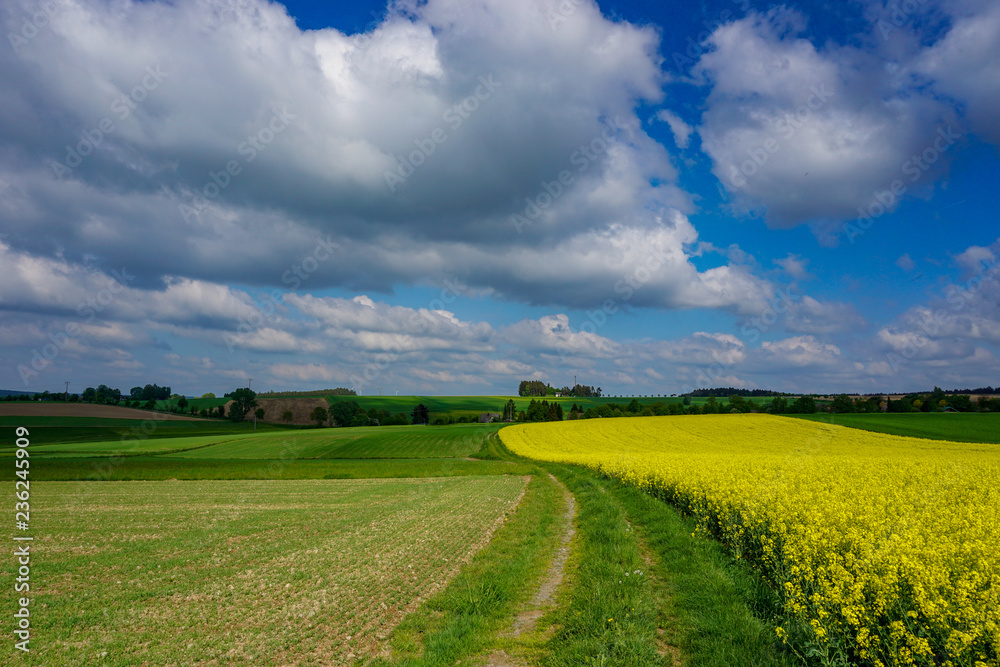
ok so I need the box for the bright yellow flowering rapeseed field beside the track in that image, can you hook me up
[500,415,1000,667]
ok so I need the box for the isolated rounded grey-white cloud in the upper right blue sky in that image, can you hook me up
[694,7,961,227]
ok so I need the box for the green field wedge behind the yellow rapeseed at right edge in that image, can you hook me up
[788,412,1000,443]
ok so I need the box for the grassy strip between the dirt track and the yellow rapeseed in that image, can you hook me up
[542,465,798,667]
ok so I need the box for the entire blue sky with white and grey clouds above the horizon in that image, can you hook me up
[0,0,1000,394]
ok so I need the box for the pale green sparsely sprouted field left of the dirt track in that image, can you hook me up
[0,475,525,666]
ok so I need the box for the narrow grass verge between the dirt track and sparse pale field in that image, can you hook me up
[374,464,563,667]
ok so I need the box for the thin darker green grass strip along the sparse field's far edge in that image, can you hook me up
[0,456,534,482]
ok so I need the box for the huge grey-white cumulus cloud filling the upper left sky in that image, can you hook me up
[0,0,772,307]
